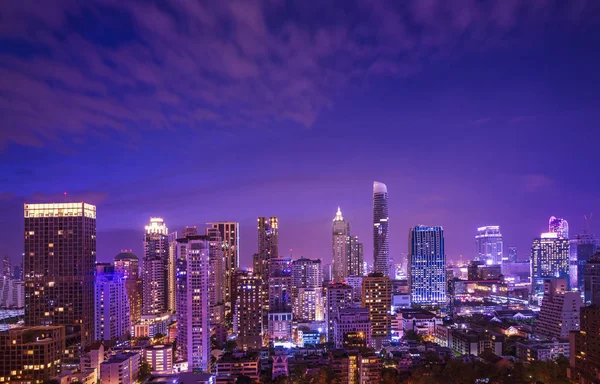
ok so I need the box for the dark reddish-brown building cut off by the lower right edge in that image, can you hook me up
[567,305,600,384]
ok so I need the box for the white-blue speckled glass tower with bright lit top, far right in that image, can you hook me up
[531,232,569,297]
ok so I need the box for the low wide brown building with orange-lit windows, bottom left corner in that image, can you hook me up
[0,326,66,383]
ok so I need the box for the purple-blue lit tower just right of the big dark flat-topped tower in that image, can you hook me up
[94,265,131,343]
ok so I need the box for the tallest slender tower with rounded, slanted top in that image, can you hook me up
[373,181,390,276]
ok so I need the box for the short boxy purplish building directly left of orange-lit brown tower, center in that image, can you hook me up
[333,308,372,349]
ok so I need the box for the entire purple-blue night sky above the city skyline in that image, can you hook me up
[0,0,600,265]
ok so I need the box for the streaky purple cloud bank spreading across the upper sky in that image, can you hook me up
[0,0,596,147]
